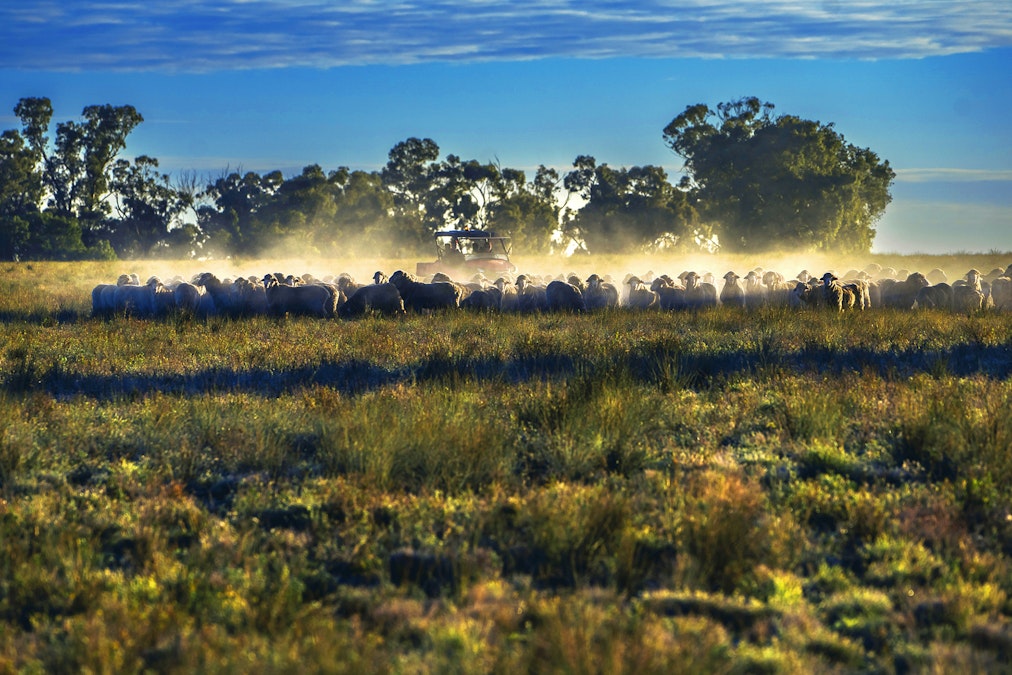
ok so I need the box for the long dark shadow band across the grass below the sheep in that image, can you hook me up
[7,345,1012,400]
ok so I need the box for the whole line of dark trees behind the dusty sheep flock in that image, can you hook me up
[0,97,895,260]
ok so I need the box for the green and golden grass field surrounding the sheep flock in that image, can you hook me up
[0,254,1012,673]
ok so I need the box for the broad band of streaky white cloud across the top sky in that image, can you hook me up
[0,0,1012,71]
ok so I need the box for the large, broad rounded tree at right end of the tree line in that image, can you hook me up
[664,97,896,253]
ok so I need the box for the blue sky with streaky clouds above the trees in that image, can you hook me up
[0,0,1012,253]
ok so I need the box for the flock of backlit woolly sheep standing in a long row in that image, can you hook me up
[91,264,1012,318]
